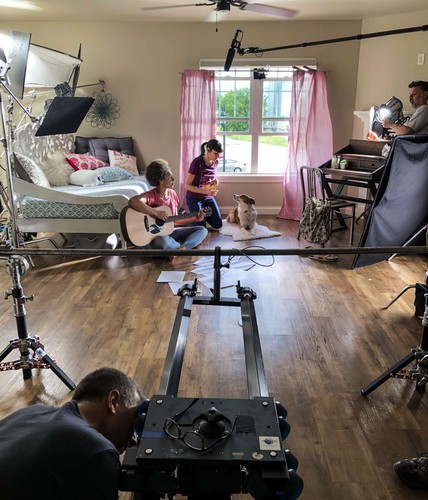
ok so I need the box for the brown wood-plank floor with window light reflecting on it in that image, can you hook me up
[0,216,428,500]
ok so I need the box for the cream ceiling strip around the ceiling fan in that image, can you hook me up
[0,0,428,22]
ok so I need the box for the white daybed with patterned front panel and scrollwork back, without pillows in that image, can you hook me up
[13,125,149,247]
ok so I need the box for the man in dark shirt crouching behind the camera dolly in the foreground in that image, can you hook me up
[0,368,148,500]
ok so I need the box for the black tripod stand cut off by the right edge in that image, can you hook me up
[361,294,428,396]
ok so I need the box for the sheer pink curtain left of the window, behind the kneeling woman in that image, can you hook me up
[179,70,216,206]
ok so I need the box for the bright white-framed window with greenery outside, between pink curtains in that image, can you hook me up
[210,66,293,175]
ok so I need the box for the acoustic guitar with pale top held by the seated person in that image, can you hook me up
[120,206,212,247]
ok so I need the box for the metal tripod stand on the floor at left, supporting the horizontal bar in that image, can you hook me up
[0,256,76,390]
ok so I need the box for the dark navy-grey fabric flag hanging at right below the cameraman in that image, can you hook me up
[352,135,428,268]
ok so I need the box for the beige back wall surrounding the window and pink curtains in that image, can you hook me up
[0,21,368,213]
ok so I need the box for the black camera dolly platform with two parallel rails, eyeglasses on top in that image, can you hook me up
[120,247,303,500]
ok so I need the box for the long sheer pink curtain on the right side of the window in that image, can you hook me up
[278,70,333,220]
